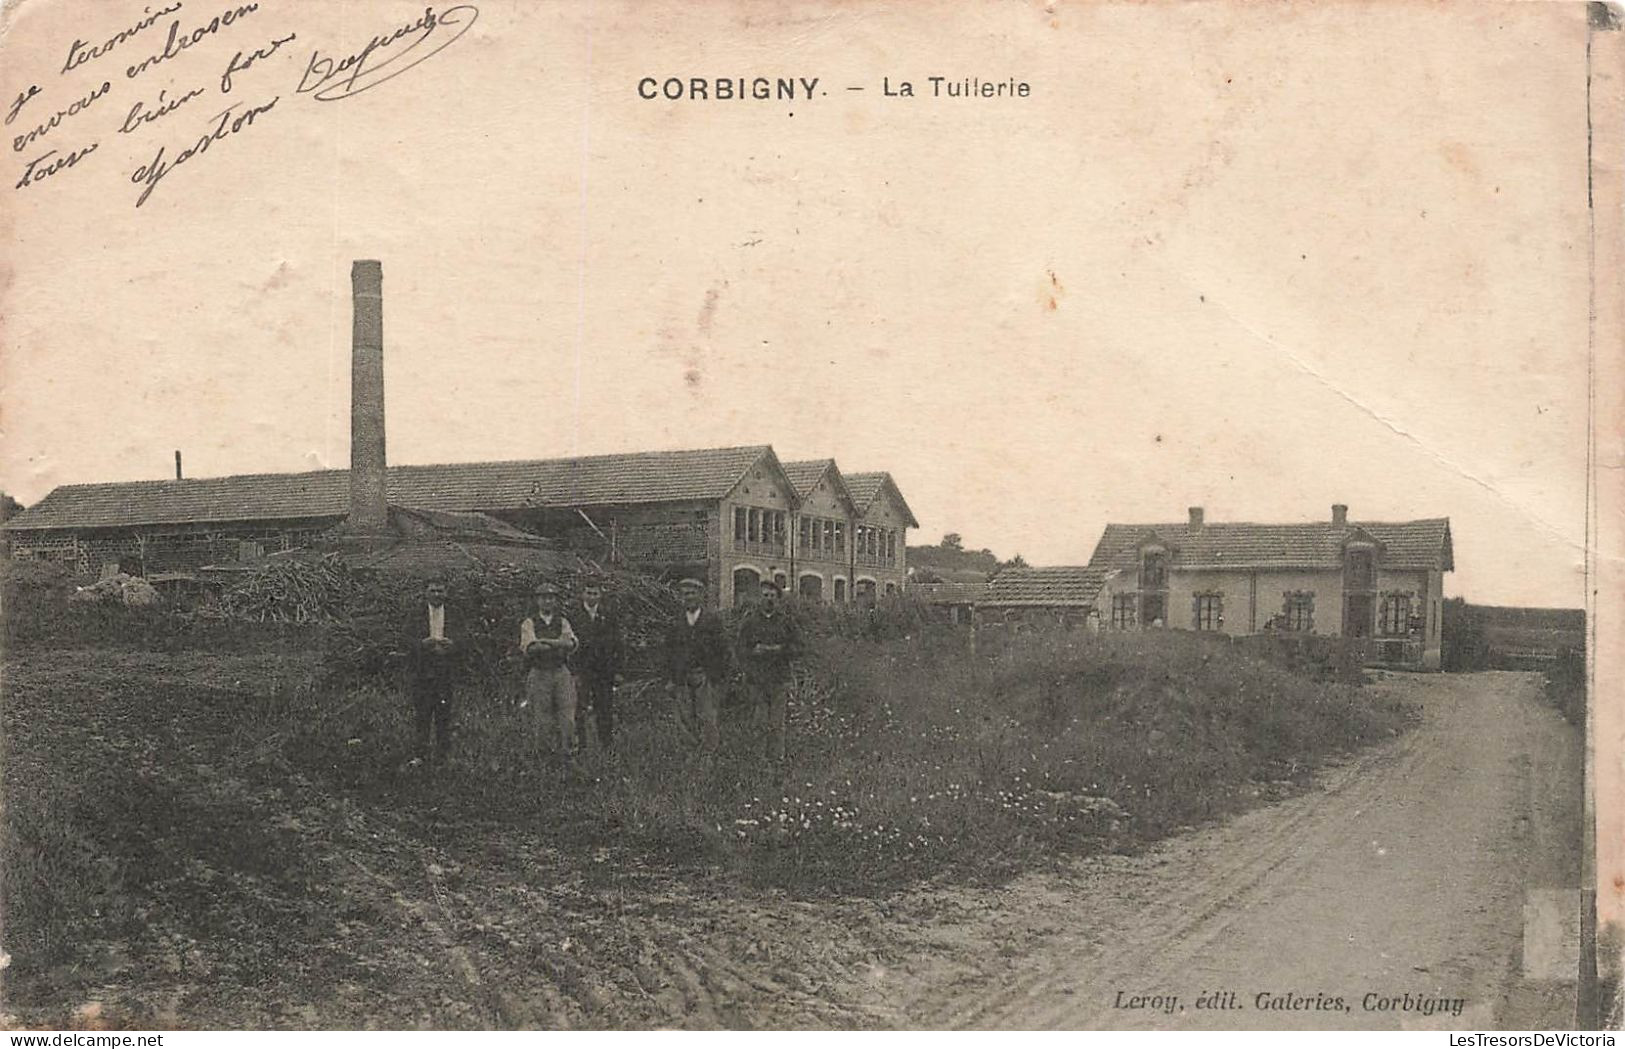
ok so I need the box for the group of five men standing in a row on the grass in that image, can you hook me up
[406,576,801,765]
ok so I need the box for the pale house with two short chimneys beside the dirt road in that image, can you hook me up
[1089,505,1454,669]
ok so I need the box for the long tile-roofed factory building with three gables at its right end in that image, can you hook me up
[3,445,918,606]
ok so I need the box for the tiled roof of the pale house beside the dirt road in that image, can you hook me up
[1089,518,1454,572]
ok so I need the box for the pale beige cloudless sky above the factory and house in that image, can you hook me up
[0,0,1589,606]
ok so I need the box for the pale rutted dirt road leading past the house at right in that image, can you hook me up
[860,672,1580,1030]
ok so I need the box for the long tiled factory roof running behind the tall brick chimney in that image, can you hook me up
[5,445,780,531]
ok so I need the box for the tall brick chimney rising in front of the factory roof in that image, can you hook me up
[349,258,390,534]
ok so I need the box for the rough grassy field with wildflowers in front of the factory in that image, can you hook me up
[0,620,1411,1028]
